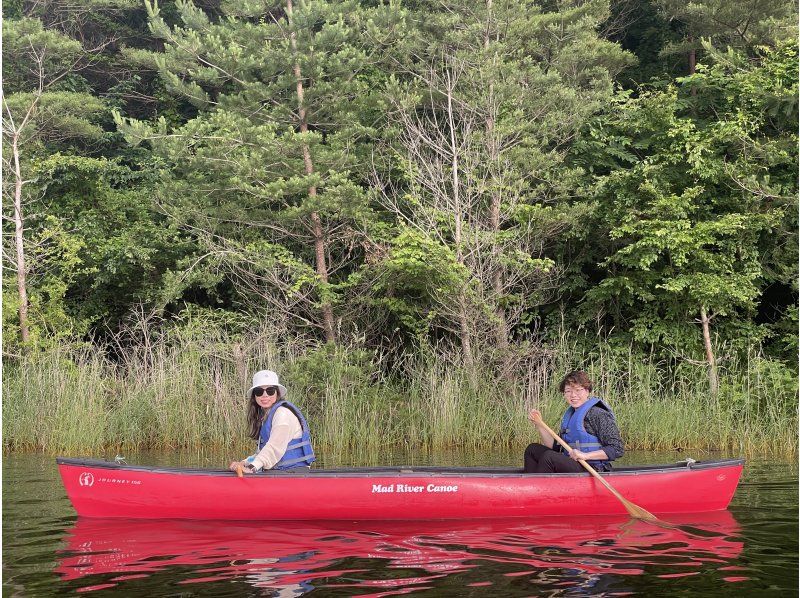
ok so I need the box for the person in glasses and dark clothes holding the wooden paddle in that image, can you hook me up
[524,370,625,473]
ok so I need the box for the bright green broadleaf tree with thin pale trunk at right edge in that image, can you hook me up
[584,44,797,392]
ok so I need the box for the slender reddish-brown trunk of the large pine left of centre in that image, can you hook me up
[286,0,336,343]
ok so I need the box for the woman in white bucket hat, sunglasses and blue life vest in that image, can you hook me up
[230,370,315,473]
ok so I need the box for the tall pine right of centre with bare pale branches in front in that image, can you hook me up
[372,0,630,366]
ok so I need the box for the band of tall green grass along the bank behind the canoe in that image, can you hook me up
[3,329,798,458]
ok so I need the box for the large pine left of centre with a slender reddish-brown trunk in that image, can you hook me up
[118,0,402,342]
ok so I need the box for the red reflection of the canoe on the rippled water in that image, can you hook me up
[56,511,743,595]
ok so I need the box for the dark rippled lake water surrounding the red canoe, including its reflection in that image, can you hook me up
[3,452,798,598]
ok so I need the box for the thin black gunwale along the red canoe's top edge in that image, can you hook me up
[56,457,744,479]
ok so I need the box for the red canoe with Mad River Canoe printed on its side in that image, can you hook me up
[57,458,743,520]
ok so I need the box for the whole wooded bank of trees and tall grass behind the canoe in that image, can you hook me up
[2,0,798,453]
